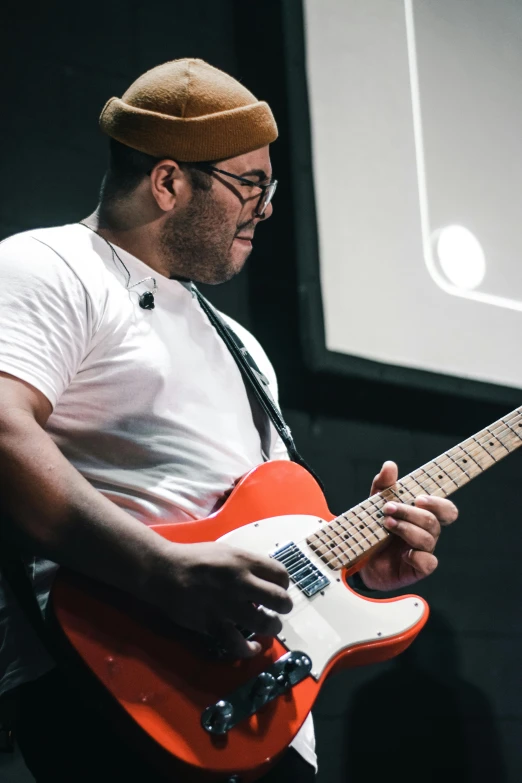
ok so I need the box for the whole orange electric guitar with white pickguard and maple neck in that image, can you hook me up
[51,407,522,782]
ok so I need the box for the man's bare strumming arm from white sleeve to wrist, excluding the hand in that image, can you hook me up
[0,373,175,594]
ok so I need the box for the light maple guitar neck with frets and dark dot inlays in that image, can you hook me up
[307,407,522,570]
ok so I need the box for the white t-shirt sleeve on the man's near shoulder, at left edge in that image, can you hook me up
[0,234,93,407]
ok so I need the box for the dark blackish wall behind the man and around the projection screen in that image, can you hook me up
[4,0,522,783]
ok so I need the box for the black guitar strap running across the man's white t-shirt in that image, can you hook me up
[192,284,324,489]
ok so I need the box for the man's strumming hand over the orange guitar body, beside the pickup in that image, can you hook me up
[148,542,292,658]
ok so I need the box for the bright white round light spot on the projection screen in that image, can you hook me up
[435,226,486,289]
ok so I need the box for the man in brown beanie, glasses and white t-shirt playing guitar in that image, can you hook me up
[0,59,457,783]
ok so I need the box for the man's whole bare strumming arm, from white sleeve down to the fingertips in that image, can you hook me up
[0,373,292,656]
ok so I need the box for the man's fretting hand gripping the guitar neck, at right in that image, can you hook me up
[360,462,459,590]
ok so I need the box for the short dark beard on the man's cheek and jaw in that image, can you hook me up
[160,190,250,285]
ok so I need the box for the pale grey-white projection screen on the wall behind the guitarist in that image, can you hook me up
[292,0,522,399]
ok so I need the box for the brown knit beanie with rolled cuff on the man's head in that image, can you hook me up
[100,59,277,163]
